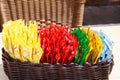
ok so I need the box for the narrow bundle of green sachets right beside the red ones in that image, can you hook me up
[72,27,90,65]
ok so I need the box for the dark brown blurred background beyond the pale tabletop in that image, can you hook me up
[0,0,120,31]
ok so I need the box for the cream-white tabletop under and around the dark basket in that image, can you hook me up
[0,24,120,80]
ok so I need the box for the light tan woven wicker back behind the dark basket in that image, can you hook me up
[1,0,85,27]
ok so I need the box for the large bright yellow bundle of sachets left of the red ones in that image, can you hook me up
[2,19,43,63]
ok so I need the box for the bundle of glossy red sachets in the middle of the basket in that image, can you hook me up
[39,24,78,64]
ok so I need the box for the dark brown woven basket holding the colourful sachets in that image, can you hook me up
[2,49,113,80]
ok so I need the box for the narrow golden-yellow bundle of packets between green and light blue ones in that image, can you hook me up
[82,26,103,63]
